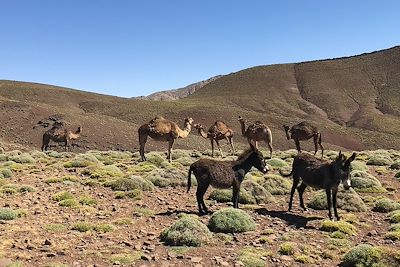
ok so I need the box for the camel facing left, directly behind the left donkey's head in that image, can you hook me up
[238,116,273,158]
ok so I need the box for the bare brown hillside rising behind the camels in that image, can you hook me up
[0,47,400,151]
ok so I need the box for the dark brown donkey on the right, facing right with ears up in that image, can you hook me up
[279,151,356,221]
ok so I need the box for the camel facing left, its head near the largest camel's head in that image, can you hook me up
[193,121,235,157]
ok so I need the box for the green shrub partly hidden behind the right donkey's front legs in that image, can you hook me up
[307,186,367,212]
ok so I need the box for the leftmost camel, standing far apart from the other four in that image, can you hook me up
[42,121,82,151]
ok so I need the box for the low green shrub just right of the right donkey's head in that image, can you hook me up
[351,171,386,193]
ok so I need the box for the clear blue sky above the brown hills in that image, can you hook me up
[0,0,400,97]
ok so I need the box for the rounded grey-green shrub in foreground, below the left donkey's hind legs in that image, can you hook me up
[160,216,212,247]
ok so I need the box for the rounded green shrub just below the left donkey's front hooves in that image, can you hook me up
[208,208,256,233]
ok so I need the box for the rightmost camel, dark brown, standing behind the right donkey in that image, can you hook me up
[283,121,324,158]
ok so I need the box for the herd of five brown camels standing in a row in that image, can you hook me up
[42,116,324,162]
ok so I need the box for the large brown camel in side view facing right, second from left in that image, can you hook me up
[138,116,193,162]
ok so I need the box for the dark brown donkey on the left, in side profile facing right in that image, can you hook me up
[187,146,269,215]
